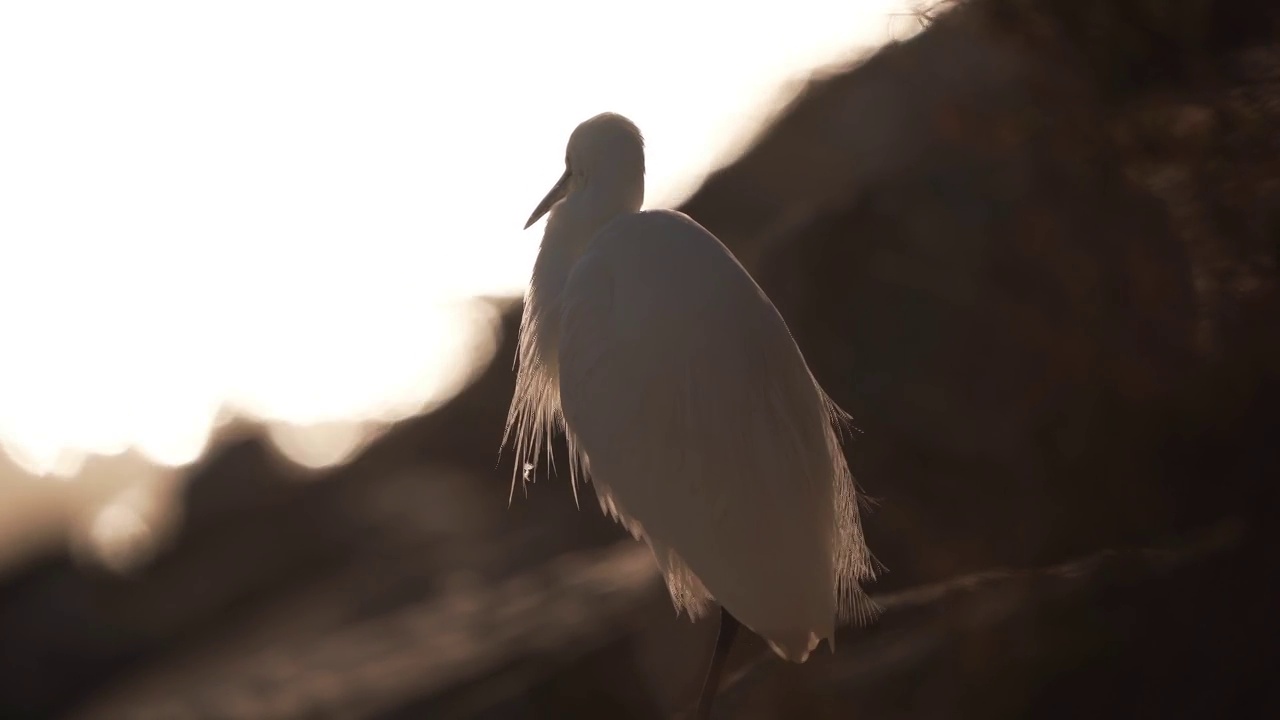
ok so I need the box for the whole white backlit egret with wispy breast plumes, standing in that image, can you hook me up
[502,113,878,717]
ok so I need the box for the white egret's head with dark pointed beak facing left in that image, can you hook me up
[525,113,644,229]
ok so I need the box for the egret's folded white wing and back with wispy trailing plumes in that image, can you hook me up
[558,211,872,659]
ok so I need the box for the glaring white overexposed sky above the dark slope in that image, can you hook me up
[0,0,910,471]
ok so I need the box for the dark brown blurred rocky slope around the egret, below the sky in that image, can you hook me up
[0,0,1280,719]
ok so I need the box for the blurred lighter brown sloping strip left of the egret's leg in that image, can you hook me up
[76,541,657,720]
